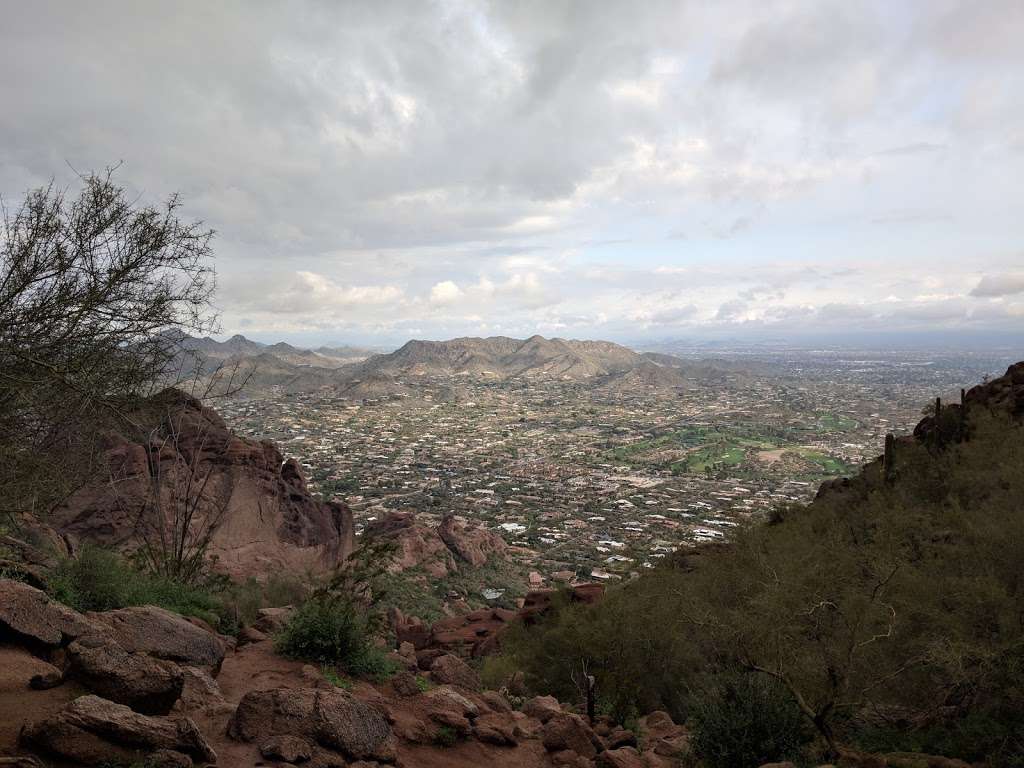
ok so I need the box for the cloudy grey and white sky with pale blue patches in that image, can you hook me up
[0,0,1024,344]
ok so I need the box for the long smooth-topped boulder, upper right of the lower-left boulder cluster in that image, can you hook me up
[89,605,225,672]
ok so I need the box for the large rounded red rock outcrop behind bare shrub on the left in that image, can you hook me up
[52,390,353,578]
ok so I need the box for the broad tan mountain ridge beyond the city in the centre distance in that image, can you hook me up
[353,336,650,380]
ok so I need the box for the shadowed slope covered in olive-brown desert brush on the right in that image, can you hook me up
[506,408,1024,766]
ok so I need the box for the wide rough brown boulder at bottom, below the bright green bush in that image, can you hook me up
[227,688,395,761]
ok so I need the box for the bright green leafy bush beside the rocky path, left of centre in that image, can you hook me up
[274,596,397,680]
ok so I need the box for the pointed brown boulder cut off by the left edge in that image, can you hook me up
[0,579,96,647]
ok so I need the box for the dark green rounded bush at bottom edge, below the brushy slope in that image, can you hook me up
[690,673,810,768]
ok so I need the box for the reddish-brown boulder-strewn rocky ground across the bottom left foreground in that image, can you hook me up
[0,580,686,768]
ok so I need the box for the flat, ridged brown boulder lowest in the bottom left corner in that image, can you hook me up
[23,695,217,765]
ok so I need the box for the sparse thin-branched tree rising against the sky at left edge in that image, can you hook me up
[0,171,216,514]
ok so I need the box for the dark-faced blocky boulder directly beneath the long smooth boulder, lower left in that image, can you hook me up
[68,638,184,715]
